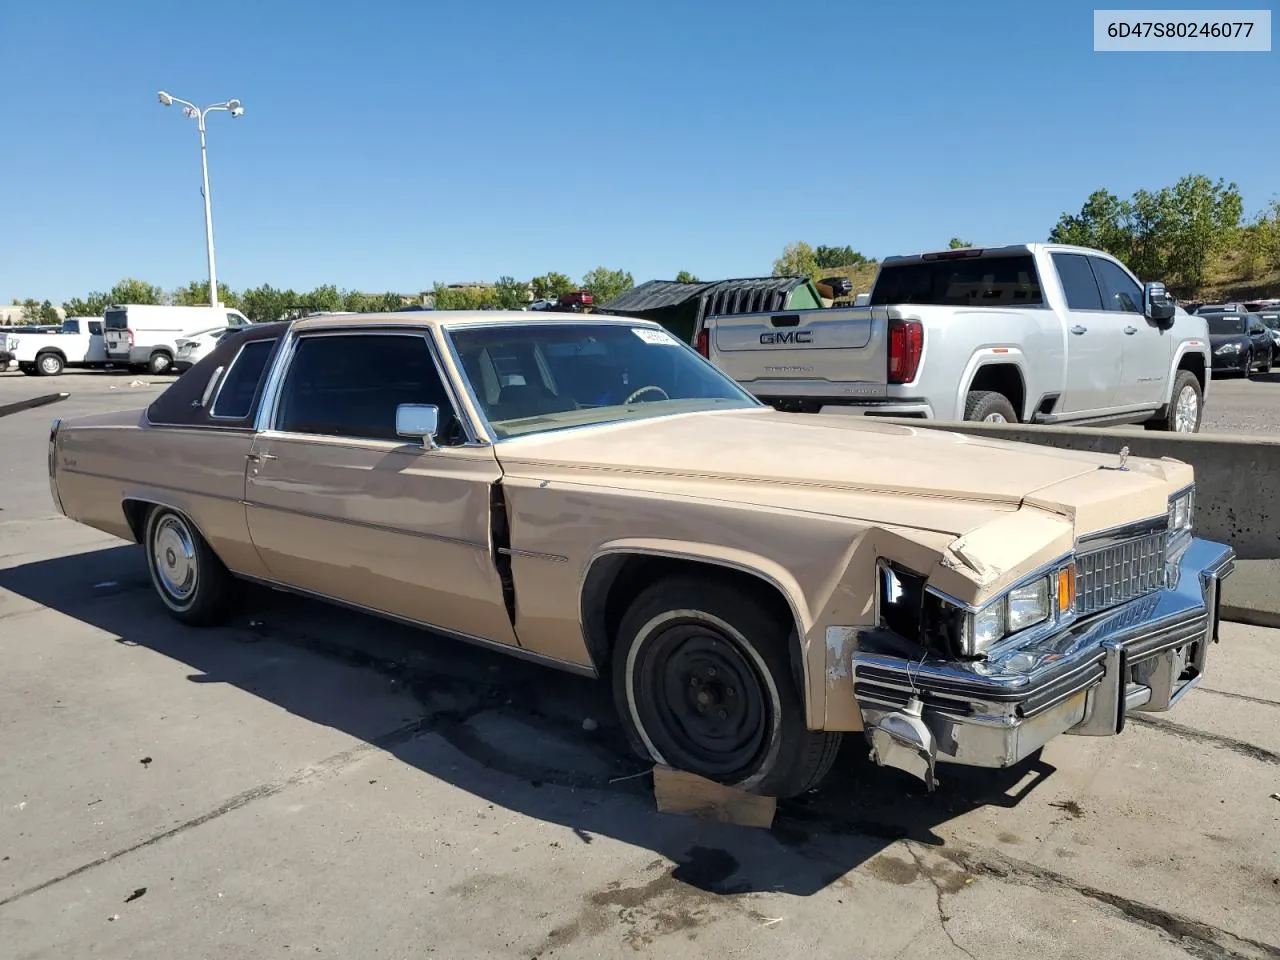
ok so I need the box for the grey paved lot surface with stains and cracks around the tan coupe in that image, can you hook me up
[0,374,1280,960]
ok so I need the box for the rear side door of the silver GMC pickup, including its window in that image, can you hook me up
[1052,252,1123,415]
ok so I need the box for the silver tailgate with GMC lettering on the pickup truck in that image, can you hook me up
[707,307,888,397]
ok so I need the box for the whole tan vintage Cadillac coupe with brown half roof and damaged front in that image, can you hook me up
[49,312,1233,796]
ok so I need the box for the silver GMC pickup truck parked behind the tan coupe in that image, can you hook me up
[699,243,1212,433]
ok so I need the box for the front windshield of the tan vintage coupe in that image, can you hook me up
[447,321,760,439]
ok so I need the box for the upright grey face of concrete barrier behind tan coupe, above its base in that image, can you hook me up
[892,419,1280,559]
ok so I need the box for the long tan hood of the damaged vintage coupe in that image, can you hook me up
[495,410,1190,535]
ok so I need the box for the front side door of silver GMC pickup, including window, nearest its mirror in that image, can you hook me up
[1089,256,1174,407]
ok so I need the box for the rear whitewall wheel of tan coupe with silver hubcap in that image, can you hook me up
[143,507,233,626]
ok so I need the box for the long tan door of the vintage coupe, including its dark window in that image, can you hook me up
[244,328,516,644]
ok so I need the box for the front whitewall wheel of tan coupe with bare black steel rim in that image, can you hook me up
[613,577,841,797]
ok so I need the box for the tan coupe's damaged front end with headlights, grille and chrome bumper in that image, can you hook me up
[851,490,1234,790]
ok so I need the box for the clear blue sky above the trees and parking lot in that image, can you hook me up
[0,0,1280,302]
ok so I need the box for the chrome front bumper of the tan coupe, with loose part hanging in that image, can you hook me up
[852,540,1235,788]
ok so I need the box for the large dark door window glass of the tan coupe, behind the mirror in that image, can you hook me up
[275,333,463,444]
